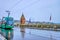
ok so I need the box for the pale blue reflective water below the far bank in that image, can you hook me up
[0,27,60,40]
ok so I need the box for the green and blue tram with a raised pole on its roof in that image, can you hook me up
[1,11,14,29]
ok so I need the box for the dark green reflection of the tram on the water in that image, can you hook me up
[0,29,13,40]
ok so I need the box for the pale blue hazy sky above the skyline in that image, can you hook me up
[0,0,60,23]
